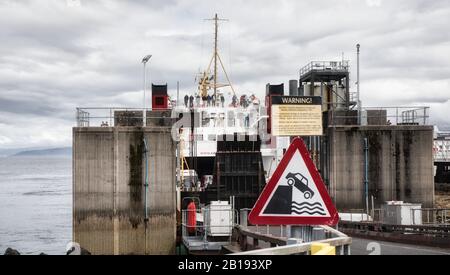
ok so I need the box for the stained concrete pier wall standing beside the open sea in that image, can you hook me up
[73,127,176,255]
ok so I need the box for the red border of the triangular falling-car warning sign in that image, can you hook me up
[249,138,339,226]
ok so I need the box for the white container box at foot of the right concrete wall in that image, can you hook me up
[382,201,422,225]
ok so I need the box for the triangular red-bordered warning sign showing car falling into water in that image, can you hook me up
[249,138,339,225]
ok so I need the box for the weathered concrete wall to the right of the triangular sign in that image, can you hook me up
[325,126,434,210]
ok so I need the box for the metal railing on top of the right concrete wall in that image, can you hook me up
[329,107,430,126]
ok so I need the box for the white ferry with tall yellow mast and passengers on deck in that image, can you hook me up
[172,14,289,209]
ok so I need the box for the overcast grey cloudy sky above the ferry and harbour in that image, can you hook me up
[0,0,450,149]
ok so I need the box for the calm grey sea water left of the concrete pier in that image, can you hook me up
[0,156,72,255]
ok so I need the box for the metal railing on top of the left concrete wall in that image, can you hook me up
[76,107,173,127]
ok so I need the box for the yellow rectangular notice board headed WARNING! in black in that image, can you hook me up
[271,96,323,136]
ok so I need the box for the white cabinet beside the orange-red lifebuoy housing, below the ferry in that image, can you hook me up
[204,201,233,237]
